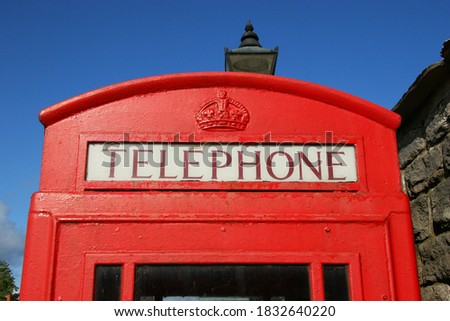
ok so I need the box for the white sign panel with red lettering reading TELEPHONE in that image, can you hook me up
[86,142,358,182]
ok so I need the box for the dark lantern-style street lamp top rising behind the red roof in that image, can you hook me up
[225,21,278,75]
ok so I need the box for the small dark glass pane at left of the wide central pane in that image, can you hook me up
[94,265,122,301]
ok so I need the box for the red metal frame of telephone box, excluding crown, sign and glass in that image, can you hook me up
[21,73,420,300]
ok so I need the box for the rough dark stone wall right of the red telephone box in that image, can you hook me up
[394,43,450,300]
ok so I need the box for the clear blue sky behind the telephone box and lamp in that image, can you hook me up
[0,0,450,282]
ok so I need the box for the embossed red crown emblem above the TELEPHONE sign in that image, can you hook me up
[195,90,250,130]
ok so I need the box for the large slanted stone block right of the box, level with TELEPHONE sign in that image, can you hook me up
[404,145,444,197]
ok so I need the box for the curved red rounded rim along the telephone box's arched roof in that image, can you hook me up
[39,72,400,129]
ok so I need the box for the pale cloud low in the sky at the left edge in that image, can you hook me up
[0,201,25,286]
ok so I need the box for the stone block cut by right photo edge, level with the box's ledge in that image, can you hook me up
[430,177,450,233]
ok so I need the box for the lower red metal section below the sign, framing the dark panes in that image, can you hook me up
[24,192,419,300]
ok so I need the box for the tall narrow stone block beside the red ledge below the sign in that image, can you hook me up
[411,194,433,242]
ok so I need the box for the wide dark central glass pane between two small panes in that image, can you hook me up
[135,264,310,301]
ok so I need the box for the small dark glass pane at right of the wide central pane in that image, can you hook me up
[323,265,350,301]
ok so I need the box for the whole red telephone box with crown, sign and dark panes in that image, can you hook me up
[21,73,420,300]
